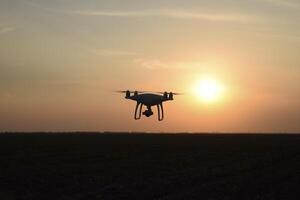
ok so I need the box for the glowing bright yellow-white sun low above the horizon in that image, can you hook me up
[193,78,223,103]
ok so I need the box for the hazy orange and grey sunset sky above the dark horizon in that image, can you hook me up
[0,0,300,133]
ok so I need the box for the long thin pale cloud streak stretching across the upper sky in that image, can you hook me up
[69,10,256,22]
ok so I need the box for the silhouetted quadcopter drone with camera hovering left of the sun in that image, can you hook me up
[116,90,181,121]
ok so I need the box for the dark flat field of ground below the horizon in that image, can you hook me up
[0,133,300,200]
